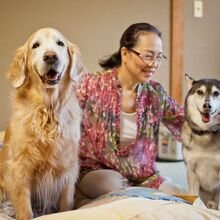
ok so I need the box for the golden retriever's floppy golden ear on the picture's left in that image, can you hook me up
[6,45,26,88]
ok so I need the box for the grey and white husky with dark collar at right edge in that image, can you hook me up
[182,75,220,210]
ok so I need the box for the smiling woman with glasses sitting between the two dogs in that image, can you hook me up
[78,23,184,206]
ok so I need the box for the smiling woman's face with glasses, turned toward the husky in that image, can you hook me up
[122,32,163,83]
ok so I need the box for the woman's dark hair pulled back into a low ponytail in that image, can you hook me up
[99,23,162,69]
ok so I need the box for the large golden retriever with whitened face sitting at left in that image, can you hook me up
[0,28,84,220]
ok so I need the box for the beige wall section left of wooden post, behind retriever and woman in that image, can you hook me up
[0,0,170,130]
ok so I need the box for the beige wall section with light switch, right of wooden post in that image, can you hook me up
[184,0,220,95]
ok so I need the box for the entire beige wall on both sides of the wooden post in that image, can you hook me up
[0,0,220,130]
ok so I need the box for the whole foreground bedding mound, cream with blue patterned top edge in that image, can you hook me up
[36,187,220,220]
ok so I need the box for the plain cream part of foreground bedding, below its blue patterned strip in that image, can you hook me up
[36,198,220,220]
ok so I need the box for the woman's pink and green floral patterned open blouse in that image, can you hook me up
[78,69,184,188]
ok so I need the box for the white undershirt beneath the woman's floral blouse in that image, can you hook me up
[120,111,137,147]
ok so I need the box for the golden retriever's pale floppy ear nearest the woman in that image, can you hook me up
[68,42,86,82]
